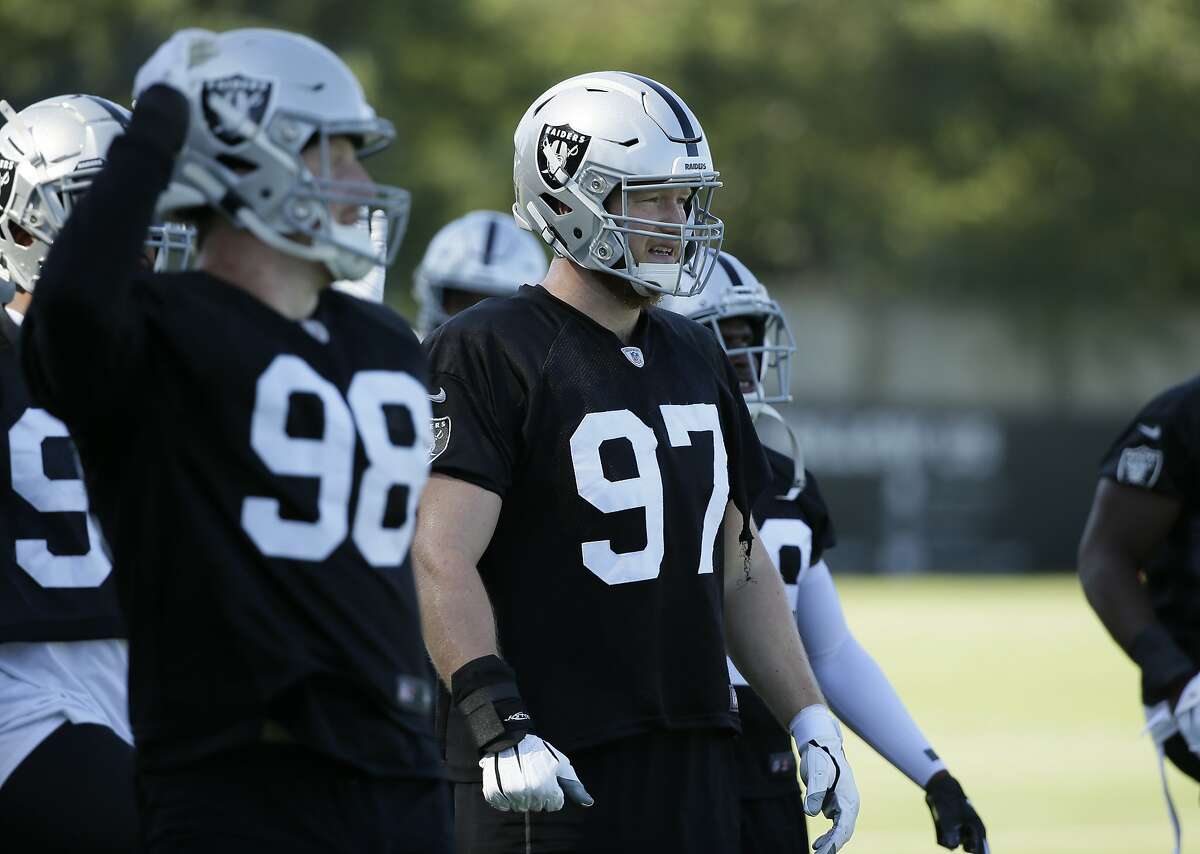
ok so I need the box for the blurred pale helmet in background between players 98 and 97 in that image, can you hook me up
[413,211,546,335]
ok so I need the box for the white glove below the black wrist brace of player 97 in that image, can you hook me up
[479,735,594,812]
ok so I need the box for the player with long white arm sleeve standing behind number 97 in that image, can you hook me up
[662,252,986,854]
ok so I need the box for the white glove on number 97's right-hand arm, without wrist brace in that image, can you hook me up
[788,705,858,854]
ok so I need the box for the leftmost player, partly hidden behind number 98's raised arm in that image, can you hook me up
[0,95,139,852]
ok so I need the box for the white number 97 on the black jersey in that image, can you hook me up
[570,403,730,584]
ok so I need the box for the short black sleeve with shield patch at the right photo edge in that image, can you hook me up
[1100,387,1200,499]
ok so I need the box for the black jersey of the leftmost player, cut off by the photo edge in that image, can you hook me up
[0,308,125,642]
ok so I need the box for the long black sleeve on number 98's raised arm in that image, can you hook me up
[22,86,188,432]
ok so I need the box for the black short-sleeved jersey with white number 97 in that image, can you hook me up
[425,287,767,764]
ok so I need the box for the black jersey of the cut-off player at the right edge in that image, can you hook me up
[1100,377,1200,702]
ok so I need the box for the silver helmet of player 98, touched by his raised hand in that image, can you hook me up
[133,29,409,279]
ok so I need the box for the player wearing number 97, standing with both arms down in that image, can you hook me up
[414,72,858,854]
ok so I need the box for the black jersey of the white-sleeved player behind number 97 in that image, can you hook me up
[734,449,835,798]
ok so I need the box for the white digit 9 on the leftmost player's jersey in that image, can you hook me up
[8,409,113,588]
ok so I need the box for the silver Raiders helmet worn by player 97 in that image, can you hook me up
[512,71,725,296]
